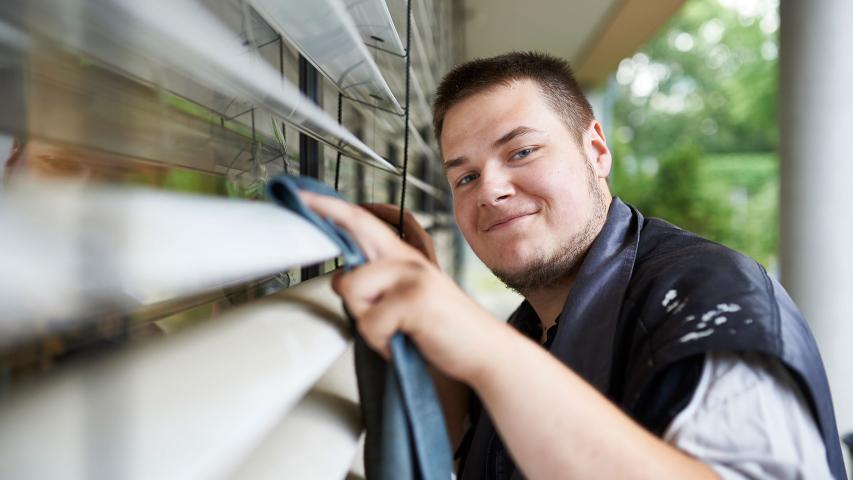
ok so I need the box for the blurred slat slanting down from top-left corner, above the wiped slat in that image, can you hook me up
[0,0,399,173]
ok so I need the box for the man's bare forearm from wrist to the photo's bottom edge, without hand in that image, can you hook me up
[471,327,716,479]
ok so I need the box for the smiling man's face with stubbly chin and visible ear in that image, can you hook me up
[441,80,610,293]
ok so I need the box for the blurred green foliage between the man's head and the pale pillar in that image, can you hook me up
[611,0,779,266]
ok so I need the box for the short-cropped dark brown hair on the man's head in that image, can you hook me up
[432,52,595,143]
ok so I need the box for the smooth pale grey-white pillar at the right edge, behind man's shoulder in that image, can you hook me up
[779,0,853,468]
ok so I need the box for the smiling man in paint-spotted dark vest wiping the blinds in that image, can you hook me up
[305,53,843,478]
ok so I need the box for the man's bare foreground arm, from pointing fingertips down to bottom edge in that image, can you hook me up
[302,194,716,479]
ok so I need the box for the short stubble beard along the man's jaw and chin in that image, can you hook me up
[492,164,607,296]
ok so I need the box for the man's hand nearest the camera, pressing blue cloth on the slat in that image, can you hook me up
[300,192,503,383]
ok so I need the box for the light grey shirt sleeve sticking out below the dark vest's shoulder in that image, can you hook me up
[664,352,832,480]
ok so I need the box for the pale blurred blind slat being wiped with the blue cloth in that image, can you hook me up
[0,181,339,343]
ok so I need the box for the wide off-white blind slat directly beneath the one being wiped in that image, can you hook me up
[0,277,348,479]
